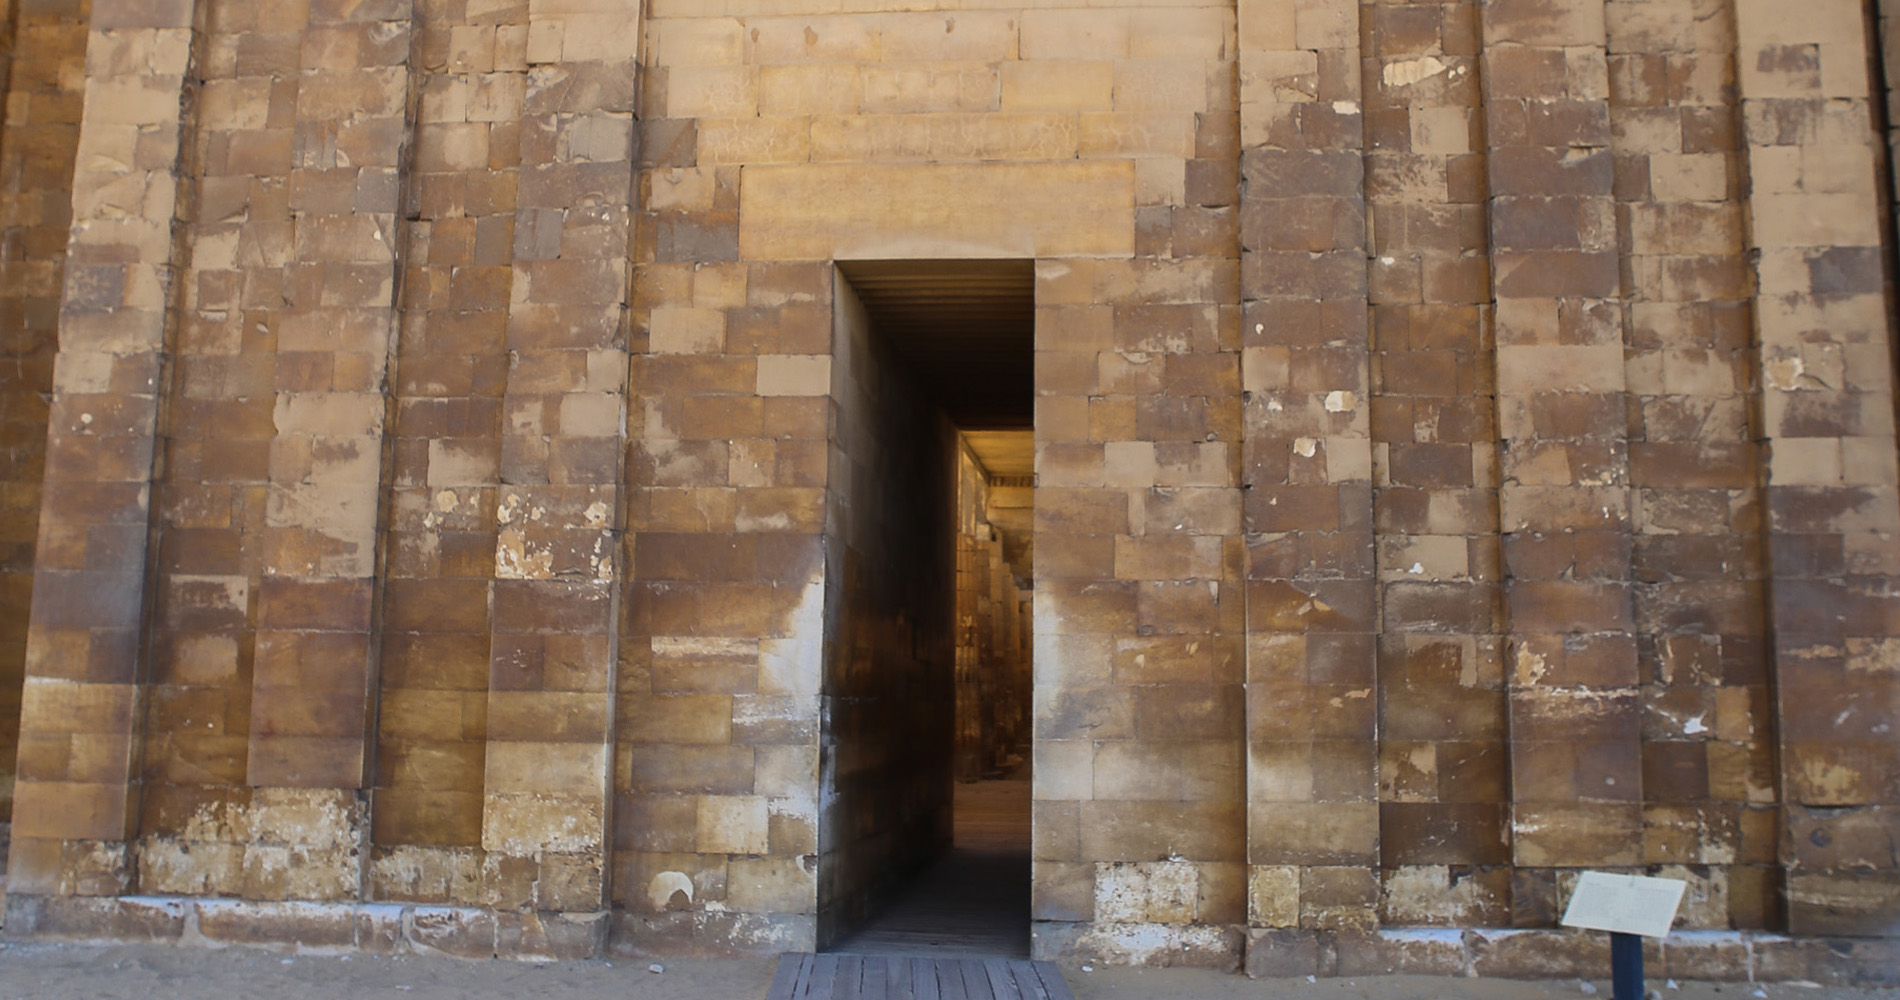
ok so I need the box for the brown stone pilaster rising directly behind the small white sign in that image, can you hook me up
[1482,0,1642,882]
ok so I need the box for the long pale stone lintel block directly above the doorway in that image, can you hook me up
[739,162,1134,260]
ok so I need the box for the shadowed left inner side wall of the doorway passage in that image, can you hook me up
[817,276,958,947]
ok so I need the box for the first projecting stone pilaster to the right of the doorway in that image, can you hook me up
[1241,0,1379,971]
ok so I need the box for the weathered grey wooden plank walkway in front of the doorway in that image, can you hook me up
[766,954,1075,1000]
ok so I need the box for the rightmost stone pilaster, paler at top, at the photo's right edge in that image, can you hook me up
[1735,0,1900,935]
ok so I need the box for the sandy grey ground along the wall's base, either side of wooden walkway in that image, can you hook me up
[0,941,1900,1000]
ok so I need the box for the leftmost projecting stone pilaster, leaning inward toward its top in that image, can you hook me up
[10,0,201,895]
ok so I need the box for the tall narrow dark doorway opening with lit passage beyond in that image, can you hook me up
[819,260,1036,956]
